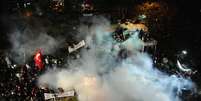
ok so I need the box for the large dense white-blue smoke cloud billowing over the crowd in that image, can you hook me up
[38,17,194,101]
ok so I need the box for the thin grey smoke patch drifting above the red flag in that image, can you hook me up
[9,27,63,63]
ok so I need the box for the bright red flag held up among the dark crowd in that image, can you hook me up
[34,50,44,70]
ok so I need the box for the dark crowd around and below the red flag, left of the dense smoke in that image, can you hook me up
[0,54,62,101]
